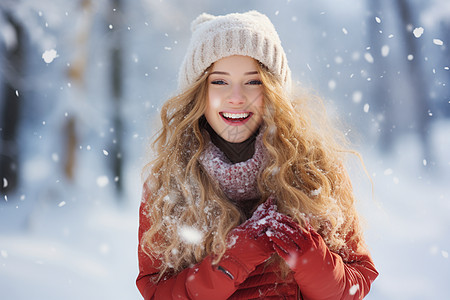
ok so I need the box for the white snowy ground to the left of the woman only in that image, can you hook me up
[0,177,139,300]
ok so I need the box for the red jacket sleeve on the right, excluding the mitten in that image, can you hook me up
[294,230,378,300]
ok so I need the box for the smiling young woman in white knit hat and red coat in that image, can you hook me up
[137,11,378,300]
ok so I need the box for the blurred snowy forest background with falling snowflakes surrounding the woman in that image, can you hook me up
[0,0,450,300]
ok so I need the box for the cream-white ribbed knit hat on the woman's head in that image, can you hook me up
[178,10,291,91]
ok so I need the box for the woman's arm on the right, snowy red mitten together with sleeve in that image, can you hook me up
[266,212,378,300]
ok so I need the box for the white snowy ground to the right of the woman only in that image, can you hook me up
[361,123,450,300]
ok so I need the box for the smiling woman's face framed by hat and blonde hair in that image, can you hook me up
[205,55,263,143]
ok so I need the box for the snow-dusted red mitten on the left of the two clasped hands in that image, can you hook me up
[217,198,276,283]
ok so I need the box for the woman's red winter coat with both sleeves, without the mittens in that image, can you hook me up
[136,192,378,300]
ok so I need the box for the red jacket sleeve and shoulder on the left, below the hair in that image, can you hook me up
[136,193,251,300]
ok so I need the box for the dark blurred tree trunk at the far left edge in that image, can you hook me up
[0,10,25,194]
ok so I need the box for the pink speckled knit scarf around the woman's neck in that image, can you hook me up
[199,133,267,202]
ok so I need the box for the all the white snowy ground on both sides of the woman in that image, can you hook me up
[0,123,450,300]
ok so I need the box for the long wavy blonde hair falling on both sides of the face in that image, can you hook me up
[141,61,362,276]
